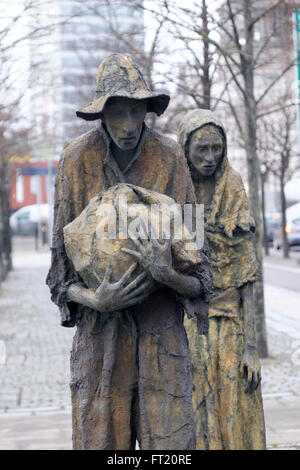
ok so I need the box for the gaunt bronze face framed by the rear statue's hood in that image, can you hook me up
[189,125,224,176]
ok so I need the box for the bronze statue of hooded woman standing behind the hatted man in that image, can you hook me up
[179,109,265,450]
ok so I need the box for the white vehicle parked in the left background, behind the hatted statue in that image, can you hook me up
[9,204,52,236]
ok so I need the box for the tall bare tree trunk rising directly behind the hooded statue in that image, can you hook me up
[241,0,268,358]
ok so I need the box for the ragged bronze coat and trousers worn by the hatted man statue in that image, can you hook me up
[47,126,211,449]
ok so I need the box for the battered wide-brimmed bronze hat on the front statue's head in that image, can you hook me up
[76,54,170,121]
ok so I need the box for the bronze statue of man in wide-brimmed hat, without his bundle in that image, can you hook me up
[47,54,211,449]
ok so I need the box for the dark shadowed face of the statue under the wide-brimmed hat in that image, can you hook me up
[102,96,147,150]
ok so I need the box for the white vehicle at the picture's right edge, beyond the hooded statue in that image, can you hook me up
[273,202,300,250]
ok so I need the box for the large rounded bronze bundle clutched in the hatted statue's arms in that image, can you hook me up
[64,183,202,290]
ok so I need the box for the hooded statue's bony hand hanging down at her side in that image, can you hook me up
[241,345,261,393]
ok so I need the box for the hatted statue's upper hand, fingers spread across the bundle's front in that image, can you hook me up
[122,219,172,282]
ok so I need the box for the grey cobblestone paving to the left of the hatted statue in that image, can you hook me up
[0,248,74,413]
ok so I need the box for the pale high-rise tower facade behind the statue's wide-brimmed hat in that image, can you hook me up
[57,0,144,145]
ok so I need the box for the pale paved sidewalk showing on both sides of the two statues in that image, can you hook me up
[0,241,300,449]
